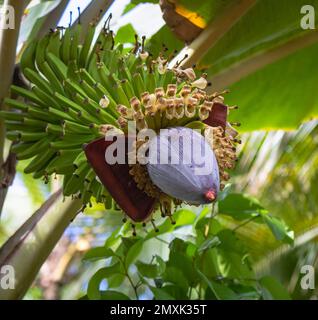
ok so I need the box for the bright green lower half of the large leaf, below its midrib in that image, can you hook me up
[227,44,318,130]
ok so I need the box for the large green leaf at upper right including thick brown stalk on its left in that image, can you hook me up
[153,0,318,131]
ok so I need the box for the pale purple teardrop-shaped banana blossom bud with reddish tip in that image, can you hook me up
[147,127,220,204]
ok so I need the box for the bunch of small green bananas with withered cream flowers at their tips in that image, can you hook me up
[0,15,235,219]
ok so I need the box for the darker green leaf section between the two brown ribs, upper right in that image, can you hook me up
[200,0,317,74]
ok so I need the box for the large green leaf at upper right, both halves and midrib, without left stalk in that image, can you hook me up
[200,0,318,131]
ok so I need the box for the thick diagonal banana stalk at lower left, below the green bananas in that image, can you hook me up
[0,190,82,300]
